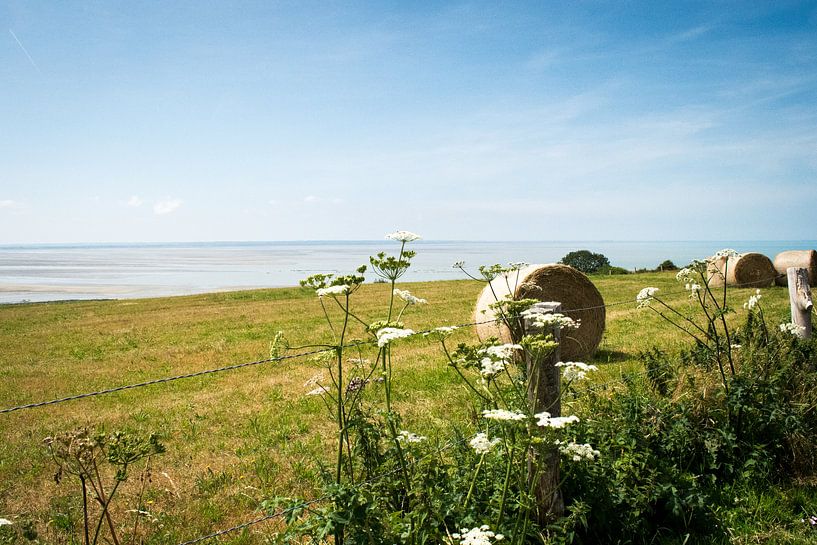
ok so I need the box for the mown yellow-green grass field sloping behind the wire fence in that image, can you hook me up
[0,273,804,543]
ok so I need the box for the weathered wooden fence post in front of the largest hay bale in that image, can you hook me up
[523,302,565,524]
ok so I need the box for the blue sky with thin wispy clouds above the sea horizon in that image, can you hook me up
[0,0,817,244]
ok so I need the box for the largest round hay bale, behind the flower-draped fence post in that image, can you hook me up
[474,264,606,361]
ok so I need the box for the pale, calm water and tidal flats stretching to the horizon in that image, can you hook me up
[0,240,817,303]
